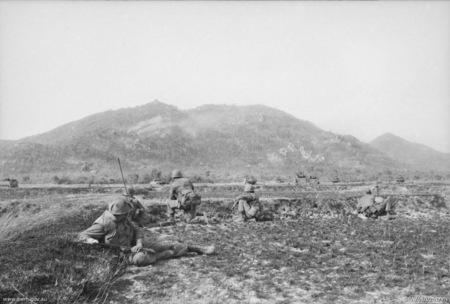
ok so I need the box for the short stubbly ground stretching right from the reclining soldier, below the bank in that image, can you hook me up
[111,213,450,303]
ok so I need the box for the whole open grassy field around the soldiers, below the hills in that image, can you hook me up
[0,184,450,303]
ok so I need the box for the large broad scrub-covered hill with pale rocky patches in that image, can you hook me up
[0,101,407,180]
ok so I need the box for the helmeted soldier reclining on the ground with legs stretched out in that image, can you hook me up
[79,197,215,266]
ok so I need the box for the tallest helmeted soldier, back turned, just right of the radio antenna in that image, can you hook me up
[167,170,201,223]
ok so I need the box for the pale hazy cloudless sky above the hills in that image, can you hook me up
[0,1,450,152]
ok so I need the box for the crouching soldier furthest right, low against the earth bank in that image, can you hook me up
[356,188,391,220]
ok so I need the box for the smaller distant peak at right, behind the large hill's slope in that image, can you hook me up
[369,133,450,171]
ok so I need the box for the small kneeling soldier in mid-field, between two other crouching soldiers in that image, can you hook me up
[234,183,262,222]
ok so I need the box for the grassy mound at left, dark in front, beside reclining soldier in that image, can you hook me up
[0,196,128,303]
